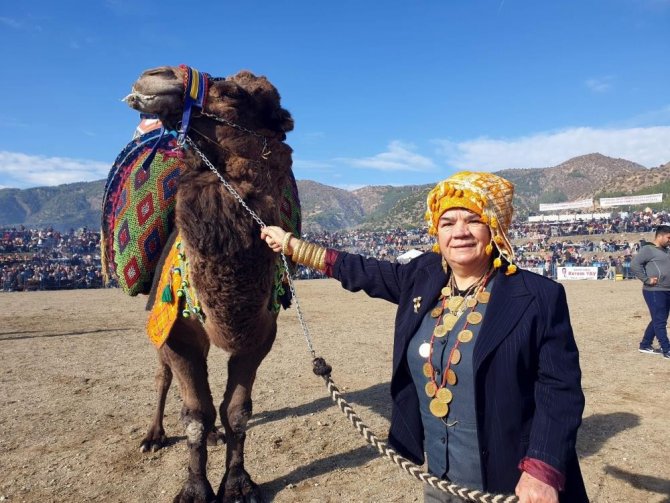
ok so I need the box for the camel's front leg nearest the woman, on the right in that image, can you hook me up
[218,320,277,503]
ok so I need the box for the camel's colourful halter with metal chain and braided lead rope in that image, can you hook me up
[152,65,519,503]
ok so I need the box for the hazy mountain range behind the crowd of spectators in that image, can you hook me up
[0,153,670,231]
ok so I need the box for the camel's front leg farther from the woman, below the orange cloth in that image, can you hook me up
[165,319,216,503]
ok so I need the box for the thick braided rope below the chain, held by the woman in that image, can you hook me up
[322,376,519,503]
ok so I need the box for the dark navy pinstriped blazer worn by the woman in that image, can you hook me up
[332,252,588,503]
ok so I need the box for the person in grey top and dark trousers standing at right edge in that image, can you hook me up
[631,225,670,360]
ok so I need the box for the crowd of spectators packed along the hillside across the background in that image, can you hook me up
[0,211,670,291]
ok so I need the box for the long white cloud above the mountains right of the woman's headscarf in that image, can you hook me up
[435,126,670,171]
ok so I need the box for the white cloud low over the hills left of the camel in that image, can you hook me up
[0,151,111,188]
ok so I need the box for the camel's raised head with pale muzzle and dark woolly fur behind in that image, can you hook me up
[124,66,293,139]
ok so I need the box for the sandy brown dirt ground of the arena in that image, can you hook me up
[0,280,670,503]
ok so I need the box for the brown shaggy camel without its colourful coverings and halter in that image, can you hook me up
[121,66,300,503]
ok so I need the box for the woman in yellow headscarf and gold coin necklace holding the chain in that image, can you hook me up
[261,172,588,503]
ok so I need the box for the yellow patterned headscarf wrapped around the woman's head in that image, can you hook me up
[425,171,516,274]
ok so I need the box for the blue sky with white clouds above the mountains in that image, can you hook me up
[0,0,670,188]
